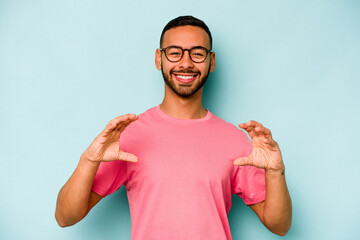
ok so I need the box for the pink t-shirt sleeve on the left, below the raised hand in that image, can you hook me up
[91,161,127,197]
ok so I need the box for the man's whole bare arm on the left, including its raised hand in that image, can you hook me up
[55,114,137,227]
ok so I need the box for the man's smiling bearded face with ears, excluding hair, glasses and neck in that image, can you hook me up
[155,26,215,98]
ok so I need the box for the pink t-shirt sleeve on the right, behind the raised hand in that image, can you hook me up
[232,130,266,205]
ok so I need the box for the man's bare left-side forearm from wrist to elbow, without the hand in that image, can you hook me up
[55,156,99,227]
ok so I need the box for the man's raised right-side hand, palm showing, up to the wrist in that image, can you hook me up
[234,121,285,171]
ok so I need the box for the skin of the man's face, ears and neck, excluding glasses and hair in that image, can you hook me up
[155,26,215,119]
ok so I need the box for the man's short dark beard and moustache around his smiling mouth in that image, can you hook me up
[161,66,210,98]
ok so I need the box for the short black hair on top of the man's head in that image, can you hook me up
[160,16,212,50]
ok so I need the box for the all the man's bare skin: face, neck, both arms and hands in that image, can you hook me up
[55,26,292,235]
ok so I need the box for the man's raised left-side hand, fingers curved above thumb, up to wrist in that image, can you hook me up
[83,114,138,162]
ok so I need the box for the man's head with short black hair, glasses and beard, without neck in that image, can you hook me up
[155,16,215,98]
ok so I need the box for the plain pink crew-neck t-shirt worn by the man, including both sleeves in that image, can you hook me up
[92,106,265,240]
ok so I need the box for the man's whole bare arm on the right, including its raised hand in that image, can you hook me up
[234,121,292,236]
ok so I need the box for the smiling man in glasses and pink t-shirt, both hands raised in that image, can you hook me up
[55,16,291,240]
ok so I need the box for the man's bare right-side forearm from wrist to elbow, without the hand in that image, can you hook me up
[263,170,292,235]
